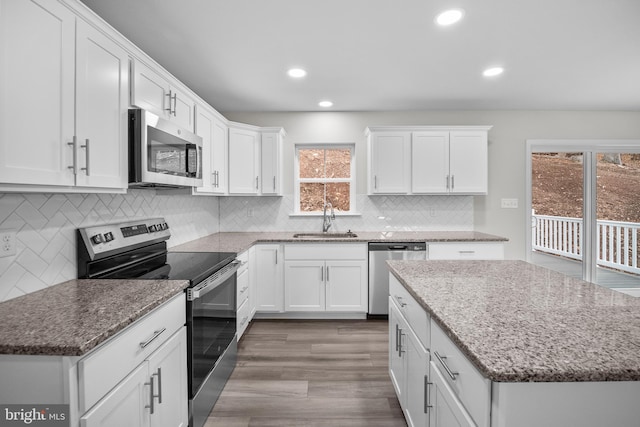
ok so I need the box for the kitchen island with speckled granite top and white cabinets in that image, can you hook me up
[388,261,640,427]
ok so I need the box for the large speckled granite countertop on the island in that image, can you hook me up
[388,261,640,382]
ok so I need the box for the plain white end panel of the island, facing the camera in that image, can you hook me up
[491,381,640,427]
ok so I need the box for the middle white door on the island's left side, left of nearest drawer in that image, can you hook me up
[402,329,429,427]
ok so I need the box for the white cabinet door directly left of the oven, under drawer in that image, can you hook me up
[149,327,189,427]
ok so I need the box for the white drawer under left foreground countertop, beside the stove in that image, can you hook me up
[78,293,186,413]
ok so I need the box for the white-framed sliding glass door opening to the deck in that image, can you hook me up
[527,140,640,294]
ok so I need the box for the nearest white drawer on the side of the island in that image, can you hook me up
[431,320,491,427]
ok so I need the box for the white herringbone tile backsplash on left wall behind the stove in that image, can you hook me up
[0,190,219,301]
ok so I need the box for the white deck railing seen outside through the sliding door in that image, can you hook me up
[532,214,640,274]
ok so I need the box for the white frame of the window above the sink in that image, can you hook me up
[293,143,356,216]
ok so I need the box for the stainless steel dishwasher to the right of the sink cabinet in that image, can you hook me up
[369,242,427,316]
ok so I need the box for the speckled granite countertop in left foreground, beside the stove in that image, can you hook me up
[0,279,189,356]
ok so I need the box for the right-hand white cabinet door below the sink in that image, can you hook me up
[325,261,368,312]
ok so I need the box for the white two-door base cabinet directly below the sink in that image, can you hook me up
[284,244,368,313]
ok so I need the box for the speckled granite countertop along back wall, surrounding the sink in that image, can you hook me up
[169,231,507,252]
